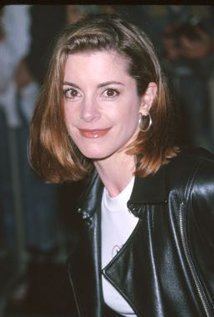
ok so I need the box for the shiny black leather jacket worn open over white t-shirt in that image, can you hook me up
[69,149,214,317]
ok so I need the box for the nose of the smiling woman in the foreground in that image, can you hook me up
[80,98,100,122]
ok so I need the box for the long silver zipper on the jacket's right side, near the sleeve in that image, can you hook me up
[179,202,211,317]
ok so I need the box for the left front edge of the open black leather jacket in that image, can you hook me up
[69,174,103,317]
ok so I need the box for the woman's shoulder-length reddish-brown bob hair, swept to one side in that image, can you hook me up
[29,14,178,183]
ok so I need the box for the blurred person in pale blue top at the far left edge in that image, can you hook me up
[0,5,30,252]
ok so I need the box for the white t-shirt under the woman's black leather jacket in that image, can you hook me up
[101,177,138,317]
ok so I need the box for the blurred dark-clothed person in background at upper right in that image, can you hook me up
[163,17,214,151]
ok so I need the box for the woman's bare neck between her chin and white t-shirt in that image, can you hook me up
[94,153,135,197]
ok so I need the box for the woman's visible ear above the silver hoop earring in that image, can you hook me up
[140,82,158,116]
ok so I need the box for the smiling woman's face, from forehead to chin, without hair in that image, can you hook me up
[63,51,155,160]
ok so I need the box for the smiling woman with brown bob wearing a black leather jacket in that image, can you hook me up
[30,15,214,317]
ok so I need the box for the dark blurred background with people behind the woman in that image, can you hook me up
[0,4,214,317]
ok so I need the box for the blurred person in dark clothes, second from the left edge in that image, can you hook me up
[5,5,65,312]
